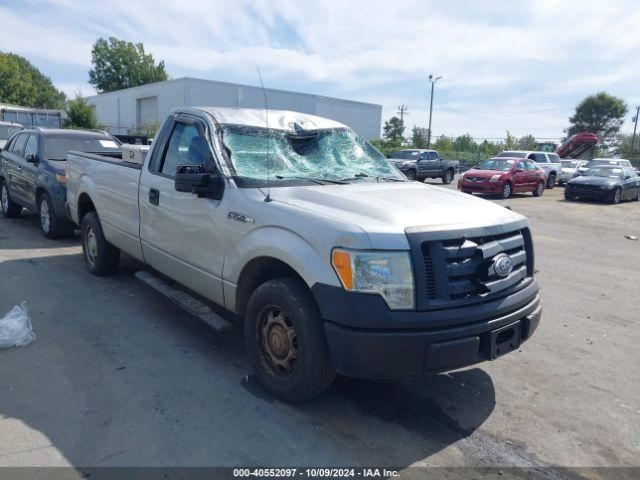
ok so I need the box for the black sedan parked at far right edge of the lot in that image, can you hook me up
[564,165,640,203]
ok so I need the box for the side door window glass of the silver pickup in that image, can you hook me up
[160,122,211,177]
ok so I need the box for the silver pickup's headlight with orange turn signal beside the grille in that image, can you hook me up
[331,248,415,310]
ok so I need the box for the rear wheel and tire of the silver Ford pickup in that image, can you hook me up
[82,212,120,277]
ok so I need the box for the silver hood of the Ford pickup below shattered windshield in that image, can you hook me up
[272,182,527,248]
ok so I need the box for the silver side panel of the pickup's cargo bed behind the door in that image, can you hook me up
[67,151,142,258]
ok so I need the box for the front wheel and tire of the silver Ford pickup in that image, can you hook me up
[245,277,335,403]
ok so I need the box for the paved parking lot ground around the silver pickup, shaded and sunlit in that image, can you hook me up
[0,180,640,468]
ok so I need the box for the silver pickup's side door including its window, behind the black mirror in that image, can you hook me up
[139,115,225,305]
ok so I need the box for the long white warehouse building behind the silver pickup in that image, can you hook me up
[87,77,382,140]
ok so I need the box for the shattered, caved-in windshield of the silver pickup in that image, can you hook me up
[221,125,404,183]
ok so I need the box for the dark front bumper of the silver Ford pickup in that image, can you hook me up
[314,282,542,378]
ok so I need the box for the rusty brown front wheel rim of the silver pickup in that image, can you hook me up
[260,306,298,377]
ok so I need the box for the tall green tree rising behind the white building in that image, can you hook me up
[89,37,169,93]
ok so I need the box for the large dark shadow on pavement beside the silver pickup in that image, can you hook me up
[0,255,495,467]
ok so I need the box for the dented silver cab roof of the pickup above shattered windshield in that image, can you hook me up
[193,107,347,131]
